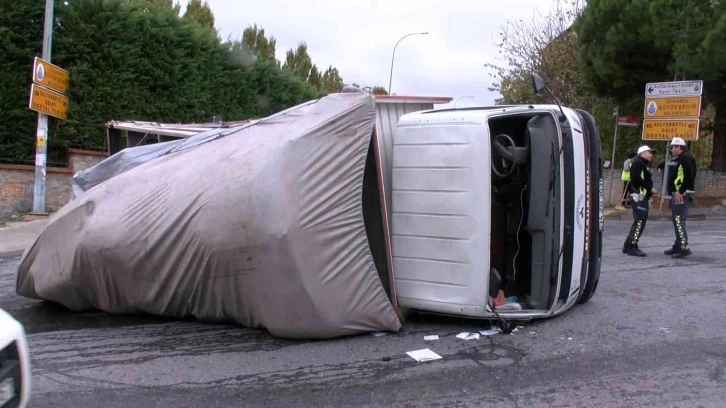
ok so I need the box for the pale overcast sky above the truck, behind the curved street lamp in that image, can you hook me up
[199,0,552,107]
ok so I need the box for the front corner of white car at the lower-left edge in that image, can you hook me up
[0,309,30,408]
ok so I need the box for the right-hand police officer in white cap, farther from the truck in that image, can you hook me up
[665,137,696,258]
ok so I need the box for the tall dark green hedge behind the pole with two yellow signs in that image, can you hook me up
[0,0,319,163]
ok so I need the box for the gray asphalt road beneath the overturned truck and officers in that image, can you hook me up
[0,221,726,408]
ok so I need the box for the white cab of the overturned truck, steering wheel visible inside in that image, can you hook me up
[390,98,603,320]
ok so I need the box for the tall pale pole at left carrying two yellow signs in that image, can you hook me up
[33,0,53,214]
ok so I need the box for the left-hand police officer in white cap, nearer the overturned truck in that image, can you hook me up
[623,146,655,257]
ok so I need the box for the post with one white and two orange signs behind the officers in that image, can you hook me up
[642,80,703,210]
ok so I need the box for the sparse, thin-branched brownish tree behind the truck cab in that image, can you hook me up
[489,0,640,164]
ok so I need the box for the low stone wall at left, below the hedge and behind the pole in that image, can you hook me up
[0,149,106,218]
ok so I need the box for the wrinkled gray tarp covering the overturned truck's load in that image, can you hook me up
[17,93,401,338]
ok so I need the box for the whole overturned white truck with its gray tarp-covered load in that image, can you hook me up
[17,81,603,338]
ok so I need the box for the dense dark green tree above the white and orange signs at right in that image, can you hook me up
[575,0,726,171]
